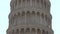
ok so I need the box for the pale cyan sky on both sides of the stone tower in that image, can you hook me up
[0,0,60,34]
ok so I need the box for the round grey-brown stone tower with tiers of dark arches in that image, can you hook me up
[7,0,53,34]
